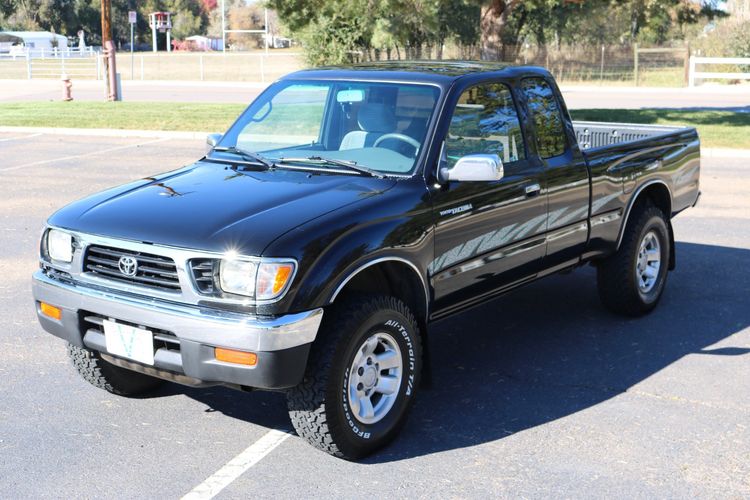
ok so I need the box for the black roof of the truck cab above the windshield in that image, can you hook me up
[282,61,548,84]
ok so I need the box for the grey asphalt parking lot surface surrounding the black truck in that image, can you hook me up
[0,133,750,498]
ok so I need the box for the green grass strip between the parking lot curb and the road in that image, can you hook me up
[0,101,750,149]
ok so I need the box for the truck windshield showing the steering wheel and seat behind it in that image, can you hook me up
[217,81,440,175]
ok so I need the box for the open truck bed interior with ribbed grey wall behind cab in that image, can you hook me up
[573,121,690,151]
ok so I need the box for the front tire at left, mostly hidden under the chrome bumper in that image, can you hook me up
[68,344,164,396]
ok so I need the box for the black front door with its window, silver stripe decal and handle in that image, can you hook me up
[429,82,547,315]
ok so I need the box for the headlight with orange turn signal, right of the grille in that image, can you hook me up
[219,258,295,300]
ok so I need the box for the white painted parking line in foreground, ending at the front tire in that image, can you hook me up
[182,429,291,500]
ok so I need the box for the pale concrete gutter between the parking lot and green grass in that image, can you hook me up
[0,126,750,159]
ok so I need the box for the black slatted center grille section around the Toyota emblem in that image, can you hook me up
[83,245,180,292]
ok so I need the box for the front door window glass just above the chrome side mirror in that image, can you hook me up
[445,83,526,168]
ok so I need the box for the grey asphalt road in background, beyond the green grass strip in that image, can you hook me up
[0,79,750,110]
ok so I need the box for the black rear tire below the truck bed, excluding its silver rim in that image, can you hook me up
[597,201,670,316]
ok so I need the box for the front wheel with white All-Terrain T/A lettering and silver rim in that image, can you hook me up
[287,296,422,460]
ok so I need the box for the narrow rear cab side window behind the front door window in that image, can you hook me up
[521,78,567,160]
